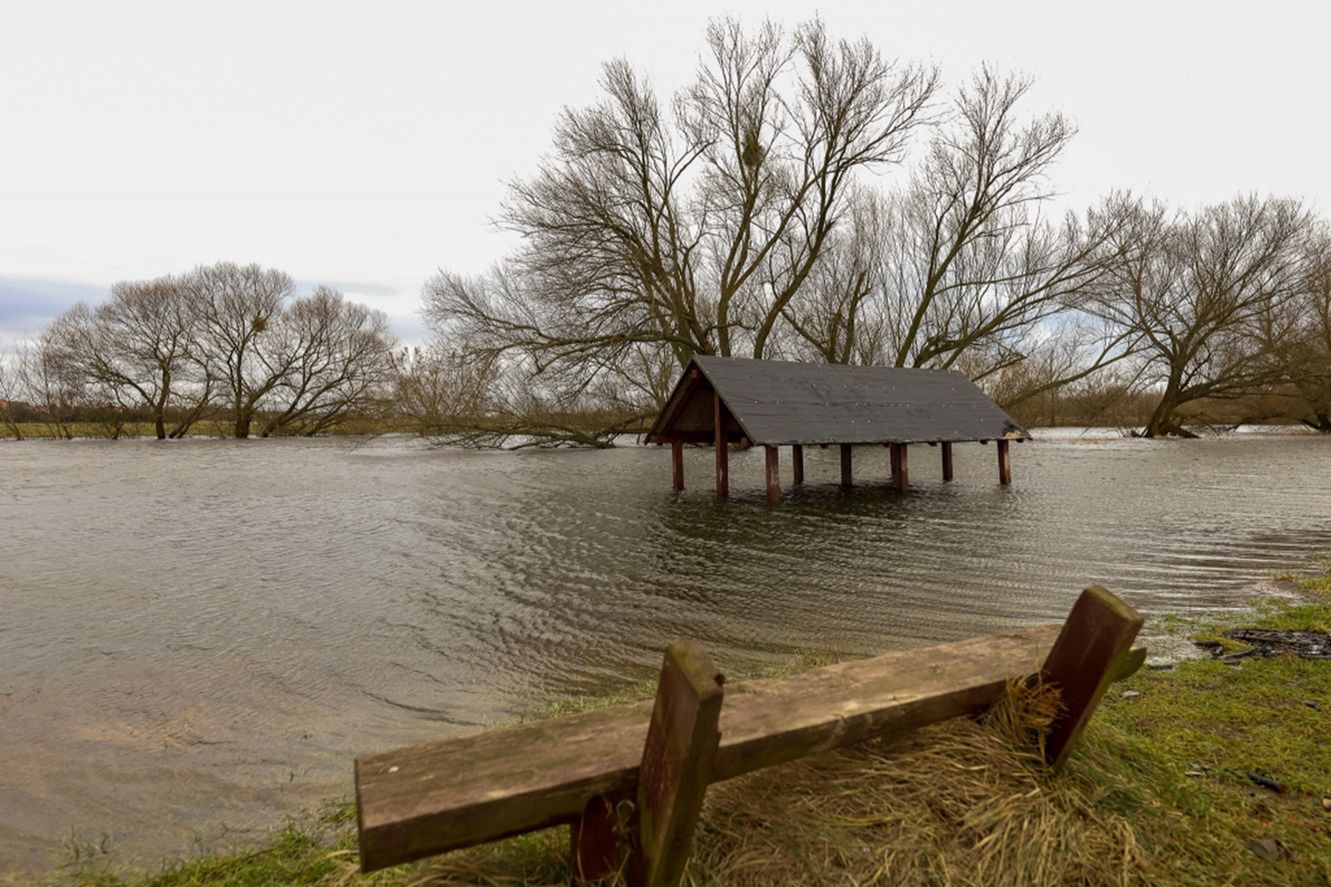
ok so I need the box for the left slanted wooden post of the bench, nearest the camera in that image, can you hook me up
[630,641,725,887]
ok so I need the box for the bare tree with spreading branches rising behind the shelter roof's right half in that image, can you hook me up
[787,68,1130,404]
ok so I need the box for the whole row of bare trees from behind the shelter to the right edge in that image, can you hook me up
[399,21,1331,442]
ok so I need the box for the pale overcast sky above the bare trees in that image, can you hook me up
[0,0,1331,348]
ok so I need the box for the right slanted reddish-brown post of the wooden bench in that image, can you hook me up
[1038,580,1143,767]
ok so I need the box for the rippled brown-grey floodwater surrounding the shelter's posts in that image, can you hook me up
[0,433,1331,871]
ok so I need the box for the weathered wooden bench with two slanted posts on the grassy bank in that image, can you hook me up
[355,586,1146,884]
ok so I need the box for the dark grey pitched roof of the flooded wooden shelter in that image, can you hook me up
[647,356,1030,446]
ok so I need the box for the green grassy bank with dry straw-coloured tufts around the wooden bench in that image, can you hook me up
[51,574,1331,887]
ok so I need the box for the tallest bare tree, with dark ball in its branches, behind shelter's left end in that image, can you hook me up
[425,21,936,407]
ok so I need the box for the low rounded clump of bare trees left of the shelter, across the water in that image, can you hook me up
[0,262,397,438]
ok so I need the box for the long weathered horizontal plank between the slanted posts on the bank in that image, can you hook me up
[355,625,1059,871]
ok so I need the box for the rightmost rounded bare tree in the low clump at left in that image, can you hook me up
[261,286,394,437]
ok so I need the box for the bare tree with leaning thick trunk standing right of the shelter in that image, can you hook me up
[1095,197,1312,437]
